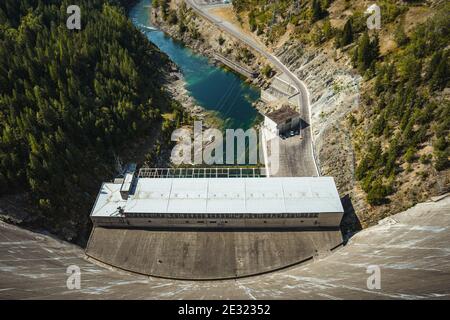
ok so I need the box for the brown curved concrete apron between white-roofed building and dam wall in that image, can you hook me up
[86,227,342,280]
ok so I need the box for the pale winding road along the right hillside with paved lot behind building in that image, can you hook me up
[185,0,320,177]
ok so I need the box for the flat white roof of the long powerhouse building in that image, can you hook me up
[92,177,343,216]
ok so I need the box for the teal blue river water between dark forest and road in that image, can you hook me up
[129,0,261,129]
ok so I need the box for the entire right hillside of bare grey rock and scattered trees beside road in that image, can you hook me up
[227,0,450,226]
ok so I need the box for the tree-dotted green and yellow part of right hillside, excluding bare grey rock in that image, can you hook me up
[233,0,450,210]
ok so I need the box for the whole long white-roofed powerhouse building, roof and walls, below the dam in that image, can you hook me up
[91,169,344,229]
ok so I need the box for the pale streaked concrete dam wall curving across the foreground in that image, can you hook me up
[0,196,450,299]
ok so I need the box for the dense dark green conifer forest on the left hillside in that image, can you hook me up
[0,0,178,242]
